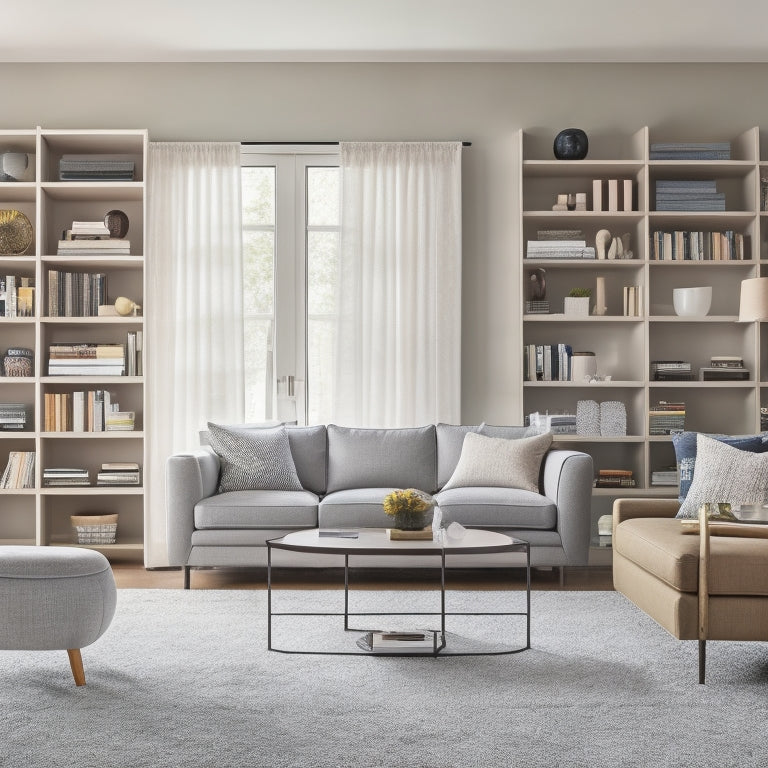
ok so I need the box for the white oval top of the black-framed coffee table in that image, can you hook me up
[268,528,525,555]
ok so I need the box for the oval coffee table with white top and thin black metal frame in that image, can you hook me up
[267,528,531,656]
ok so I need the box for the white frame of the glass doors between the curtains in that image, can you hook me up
[240,144,340,424]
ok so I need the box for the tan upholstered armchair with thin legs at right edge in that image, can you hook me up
[613,499,768,683]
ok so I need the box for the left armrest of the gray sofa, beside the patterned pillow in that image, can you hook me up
[165,449,219,565]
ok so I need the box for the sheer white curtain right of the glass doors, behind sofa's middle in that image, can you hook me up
[333,142,461,427]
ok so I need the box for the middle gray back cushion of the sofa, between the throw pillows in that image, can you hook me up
[327,424,437,496]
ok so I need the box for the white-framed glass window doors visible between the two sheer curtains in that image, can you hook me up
[242,146,340,424]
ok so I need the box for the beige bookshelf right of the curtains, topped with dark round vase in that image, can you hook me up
[518,127,768,563]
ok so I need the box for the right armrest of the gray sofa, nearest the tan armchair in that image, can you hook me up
[543,450,593,565]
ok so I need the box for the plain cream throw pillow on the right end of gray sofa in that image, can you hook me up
[443,432,552,493]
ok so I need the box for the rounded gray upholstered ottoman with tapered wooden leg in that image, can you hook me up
[0,546,117,685]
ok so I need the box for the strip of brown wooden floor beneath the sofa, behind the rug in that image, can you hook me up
[112,562,613,591]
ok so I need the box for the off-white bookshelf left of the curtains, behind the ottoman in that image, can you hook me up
[0,128,148,559]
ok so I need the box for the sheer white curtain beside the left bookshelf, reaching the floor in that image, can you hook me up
[145,142,244,564]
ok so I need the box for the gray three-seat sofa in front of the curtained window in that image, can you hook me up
[166,424,593,587]
